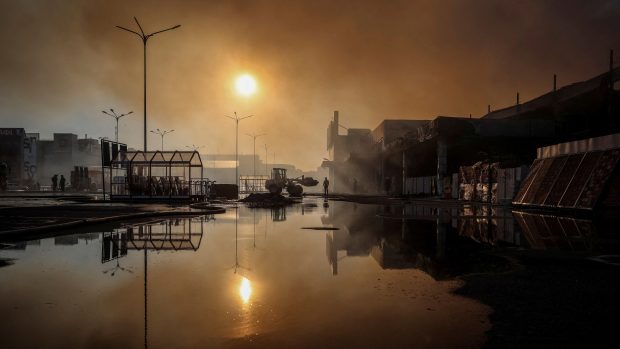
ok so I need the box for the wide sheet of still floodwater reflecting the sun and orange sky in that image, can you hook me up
[0,198,618,348]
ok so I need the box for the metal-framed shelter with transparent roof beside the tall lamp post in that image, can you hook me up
[109,151,205,200]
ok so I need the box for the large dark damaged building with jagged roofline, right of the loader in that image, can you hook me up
[323,62,620,203]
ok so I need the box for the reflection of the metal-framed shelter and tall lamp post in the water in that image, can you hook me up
[101,215,208,348]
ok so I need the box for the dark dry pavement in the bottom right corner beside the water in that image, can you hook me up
[455,250,620,349]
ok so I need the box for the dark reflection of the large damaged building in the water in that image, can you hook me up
[322,204,620,279]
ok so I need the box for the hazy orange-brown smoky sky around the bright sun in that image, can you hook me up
[0,0,620,169]
